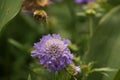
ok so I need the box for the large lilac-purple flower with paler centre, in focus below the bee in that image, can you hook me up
[31,34,73,72]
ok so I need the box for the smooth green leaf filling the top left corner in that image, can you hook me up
[0,0,23,32]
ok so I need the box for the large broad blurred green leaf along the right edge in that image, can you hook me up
[85,6,120,80]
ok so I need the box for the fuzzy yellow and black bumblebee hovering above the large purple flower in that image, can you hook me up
[33,10,48,22]
